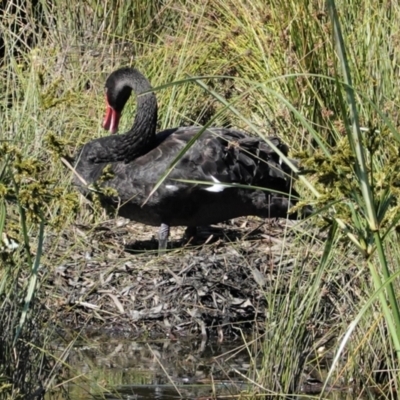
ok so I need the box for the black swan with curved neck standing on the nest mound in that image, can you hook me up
[74,68,310,250]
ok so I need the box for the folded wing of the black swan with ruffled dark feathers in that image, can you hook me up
[106,127,290,196]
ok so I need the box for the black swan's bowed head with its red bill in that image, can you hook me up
[103,68,132,133]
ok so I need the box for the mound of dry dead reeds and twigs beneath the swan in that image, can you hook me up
[43,218,311,339]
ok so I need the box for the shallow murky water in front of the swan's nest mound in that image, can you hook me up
[46,338,254,400]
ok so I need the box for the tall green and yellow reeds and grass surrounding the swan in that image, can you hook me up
[0,0,400,398]
